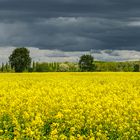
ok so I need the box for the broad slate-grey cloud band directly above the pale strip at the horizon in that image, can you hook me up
[0,17,140,51]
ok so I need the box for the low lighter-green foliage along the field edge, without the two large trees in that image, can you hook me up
[0,61,140,72]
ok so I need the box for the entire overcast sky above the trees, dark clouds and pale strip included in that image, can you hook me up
[0,0,140,62]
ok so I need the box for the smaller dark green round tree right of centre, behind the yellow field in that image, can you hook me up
[79,55,95,71]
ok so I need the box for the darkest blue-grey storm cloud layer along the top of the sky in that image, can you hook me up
[0,0,140,19]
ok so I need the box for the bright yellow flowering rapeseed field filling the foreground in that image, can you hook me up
[0,73,140,140]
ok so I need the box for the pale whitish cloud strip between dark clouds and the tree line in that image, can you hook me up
[0,46,140,64]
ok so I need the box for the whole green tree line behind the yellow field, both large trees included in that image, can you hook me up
[0,48,140,72]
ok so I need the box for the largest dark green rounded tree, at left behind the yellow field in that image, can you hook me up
[9,47,31,72]
